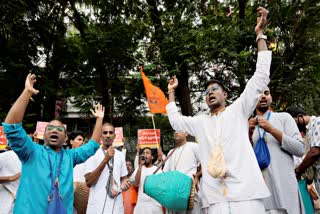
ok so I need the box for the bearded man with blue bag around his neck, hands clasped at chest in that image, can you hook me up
[249,88,304,214]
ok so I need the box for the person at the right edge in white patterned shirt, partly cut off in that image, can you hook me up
[287,107,320,196]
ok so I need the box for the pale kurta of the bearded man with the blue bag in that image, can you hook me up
[252,112,304,214]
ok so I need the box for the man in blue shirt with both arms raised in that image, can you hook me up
[3,74,104,213]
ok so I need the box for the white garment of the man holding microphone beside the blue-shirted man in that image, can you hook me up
[85,149,128,214]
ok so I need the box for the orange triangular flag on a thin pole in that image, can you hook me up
[140,66,168,114]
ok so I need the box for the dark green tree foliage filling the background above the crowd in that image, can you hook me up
[0,0,320,149]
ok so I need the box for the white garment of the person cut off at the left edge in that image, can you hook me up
[0,150,21,214]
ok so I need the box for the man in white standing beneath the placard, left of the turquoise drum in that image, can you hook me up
[131,147,163,214]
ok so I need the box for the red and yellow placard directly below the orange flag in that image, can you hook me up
[138,129,160,149]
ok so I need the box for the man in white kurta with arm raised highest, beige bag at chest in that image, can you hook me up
[167,7,271,214]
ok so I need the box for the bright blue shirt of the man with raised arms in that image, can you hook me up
[2,123,99,214]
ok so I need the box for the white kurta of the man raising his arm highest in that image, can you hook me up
[166,51,271,205]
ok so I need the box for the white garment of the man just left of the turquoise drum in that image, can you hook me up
[130,166,163,214]
